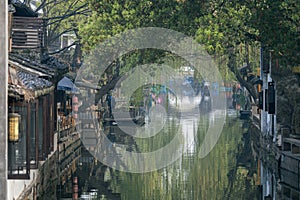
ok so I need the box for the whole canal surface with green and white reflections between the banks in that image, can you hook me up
[56,79,300,200]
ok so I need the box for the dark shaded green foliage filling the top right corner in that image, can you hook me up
[248,0,300,65]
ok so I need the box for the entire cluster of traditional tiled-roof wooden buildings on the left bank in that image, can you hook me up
[7,1,80,199]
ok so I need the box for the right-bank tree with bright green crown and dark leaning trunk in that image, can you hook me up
[196,1,259,99]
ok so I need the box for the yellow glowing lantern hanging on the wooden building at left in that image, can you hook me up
[8,113,20,142]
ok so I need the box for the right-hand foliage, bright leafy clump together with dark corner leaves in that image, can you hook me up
[196,0,300,65]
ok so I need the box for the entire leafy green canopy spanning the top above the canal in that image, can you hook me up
[78,0,300,85]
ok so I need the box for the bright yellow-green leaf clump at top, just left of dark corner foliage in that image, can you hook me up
[196,2,257,54]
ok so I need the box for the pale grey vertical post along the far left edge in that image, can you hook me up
[0,0,8,200]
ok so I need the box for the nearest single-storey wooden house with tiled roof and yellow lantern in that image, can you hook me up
[8,53,56,179]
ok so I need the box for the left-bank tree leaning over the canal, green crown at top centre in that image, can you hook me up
[79,0,209,99]
